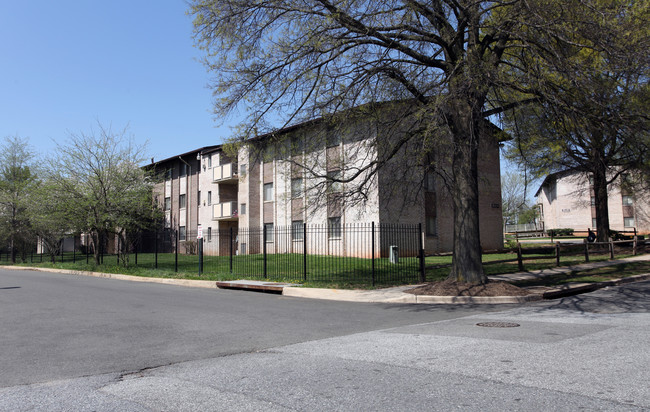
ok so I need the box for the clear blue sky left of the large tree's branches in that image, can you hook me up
[0,0,232,160]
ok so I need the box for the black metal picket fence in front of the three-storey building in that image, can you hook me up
[0,223,424,285]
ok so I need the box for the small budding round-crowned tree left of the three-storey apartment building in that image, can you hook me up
[48,123,153,264]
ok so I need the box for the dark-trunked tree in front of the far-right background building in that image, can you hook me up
[506,2,650,241]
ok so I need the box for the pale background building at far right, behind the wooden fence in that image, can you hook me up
[535,171,650,233]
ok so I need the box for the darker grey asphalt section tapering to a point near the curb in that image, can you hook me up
[0,269,506,387]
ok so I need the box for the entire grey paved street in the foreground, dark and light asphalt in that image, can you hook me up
[0,270,650,411]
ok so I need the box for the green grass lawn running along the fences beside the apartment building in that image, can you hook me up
[0,248,644,289]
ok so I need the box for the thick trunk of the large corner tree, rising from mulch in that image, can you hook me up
[448,99,487,283]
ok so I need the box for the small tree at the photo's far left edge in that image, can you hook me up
[0,136,37,263]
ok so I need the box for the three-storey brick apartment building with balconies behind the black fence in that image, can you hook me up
[155,108,503,256]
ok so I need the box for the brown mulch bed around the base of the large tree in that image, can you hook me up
[405,279,531,296]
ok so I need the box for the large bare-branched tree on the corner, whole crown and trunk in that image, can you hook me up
[190,0,636,282]
